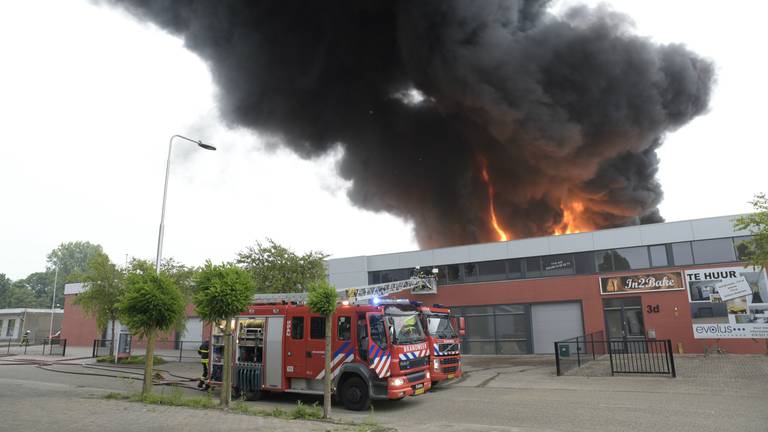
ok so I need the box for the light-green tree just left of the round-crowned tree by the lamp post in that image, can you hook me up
[75,252,125,355]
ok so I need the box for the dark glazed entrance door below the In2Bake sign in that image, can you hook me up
[603,297,645,349]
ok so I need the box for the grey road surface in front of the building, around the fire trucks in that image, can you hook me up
[0,356,768,432]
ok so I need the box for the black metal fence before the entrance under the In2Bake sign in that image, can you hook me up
[555,331,677,378]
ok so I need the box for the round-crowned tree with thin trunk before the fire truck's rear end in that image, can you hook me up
[194,261,256,407]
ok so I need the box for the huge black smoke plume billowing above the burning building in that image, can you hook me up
[105,0,714,247]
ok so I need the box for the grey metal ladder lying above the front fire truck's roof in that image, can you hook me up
[253,276,437,303]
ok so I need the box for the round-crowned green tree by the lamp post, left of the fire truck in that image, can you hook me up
[117,260,185,396]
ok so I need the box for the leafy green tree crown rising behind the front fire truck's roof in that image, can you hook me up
[236,239,328,293]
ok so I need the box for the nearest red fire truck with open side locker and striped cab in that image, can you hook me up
[210,298,431,410]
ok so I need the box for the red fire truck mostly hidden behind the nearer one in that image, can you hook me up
[417,305,464,385]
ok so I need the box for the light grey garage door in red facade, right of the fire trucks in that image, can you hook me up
[531,302,584,354]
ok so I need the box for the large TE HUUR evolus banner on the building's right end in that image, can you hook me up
[685,267,768,339]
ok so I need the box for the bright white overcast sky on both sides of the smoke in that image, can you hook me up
[0,0,768,279]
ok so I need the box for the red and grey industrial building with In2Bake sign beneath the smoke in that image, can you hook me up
[328,216,768,355]
